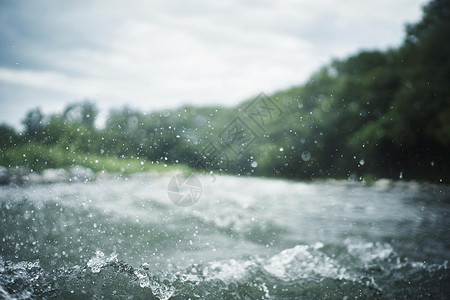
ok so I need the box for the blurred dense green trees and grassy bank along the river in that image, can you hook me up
[0,0,450,183]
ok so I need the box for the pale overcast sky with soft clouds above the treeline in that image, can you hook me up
[0,0,426,129]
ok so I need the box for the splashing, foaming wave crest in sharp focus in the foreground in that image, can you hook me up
[0,242,449,299]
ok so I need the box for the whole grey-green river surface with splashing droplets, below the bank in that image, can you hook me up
[0,175,450,299]
